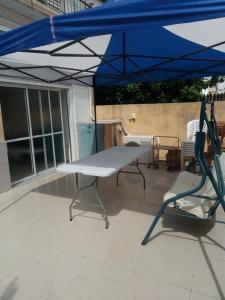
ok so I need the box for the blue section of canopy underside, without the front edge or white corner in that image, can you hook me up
[96,27,225,86]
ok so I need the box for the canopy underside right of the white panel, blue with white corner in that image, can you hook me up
[96,18,225,86]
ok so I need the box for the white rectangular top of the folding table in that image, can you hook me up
[57,146,149,177]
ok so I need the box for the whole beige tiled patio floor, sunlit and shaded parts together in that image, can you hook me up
[0,166,225,300]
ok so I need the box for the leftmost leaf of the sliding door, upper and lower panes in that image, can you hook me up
[0,87,34,181]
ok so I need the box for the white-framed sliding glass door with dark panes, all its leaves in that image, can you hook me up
[0,87,65,182]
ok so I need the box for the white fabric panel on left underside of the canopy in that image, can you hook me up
[0,35,111,86]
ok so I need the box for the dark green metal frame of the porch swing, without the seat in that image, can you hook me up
[141,97,225,245]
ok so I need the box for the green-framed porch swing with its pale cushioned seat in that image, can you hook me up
[142,97,225,245]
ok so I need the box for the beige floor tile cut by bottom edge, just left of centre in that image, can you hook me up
[54,259,130,300]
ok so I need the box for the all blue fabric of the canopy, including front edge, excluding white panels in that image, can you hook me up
[0,0,225,86]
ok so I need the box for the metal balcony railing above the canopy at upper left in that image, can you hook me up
[38,0,92,13]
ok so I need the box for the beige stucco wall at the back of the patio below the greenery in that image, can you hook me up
[97,101,225,139]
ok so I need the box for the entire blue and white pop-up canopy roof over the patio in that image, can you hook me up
[0,0,225,86]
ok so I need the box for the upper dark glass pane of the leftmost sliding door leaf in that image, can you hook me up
[0,87,29,140]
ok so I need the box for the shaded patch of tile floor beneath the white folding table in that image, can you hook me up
[31,174,156,216]
